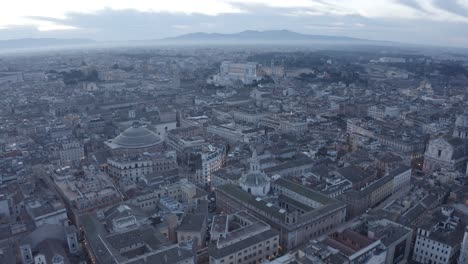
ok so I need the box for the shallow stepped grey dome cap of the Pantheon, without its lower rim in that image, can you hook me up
[111,125,161,148]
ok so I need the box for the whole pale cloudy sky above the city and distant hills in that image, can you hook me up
[0,0,468,47]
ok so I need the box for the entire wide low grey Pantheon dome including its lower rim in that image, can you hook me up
[105,123,163,152]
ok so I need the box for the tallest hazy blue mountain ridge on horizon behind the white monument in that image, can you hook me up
[162,30,382,43]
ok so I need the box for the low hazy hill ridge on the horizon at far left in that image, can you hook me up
[0,38,94,50]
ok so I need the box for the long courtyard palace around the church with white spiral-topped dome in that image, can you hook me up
[216,178,346,250]
